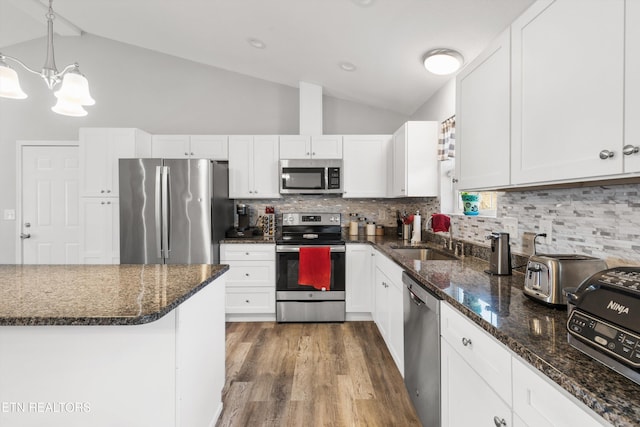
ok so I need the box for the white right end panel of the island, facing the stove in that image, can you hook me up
[176,275,226,427]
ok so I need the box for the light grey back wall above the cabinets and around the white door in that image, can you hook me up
[0,35,407,264]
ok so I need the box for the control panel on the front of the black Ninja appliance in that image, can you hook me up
[567,309,640,369]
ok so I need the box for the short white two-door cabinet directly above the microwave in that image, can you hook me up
[280,135,342,159]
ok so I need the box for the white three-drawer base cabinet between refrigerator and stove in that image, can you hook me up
[220,244,276,321]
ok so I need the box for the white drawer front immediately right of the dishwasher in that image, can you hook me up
[440,303,512,406]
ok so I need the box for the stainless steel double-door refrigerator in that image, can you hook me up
[119,159,233,264]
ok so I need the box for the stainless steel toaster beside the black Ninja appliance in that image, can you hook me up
[524,254,607,306]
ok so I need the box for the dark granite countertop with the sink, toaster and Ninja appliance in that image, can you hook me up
[345,236,640,426]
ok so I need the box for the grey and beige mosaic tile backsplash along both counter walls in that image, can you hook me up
[238,184,640,267]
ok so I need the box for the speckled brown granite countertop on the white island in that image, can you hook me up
[0,265,229,326]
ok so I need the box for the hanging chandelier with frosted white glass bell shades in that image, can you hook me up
[0,0,96,117]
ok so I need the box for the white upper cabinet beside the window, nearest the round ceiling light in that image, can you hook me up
[456,30,511,190]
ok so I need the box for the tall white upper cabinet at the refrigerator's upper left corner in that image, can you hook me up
[79,128,151,197]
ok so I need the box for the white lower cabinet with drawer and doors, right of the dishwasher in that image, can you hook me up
[440,303,610,427]
